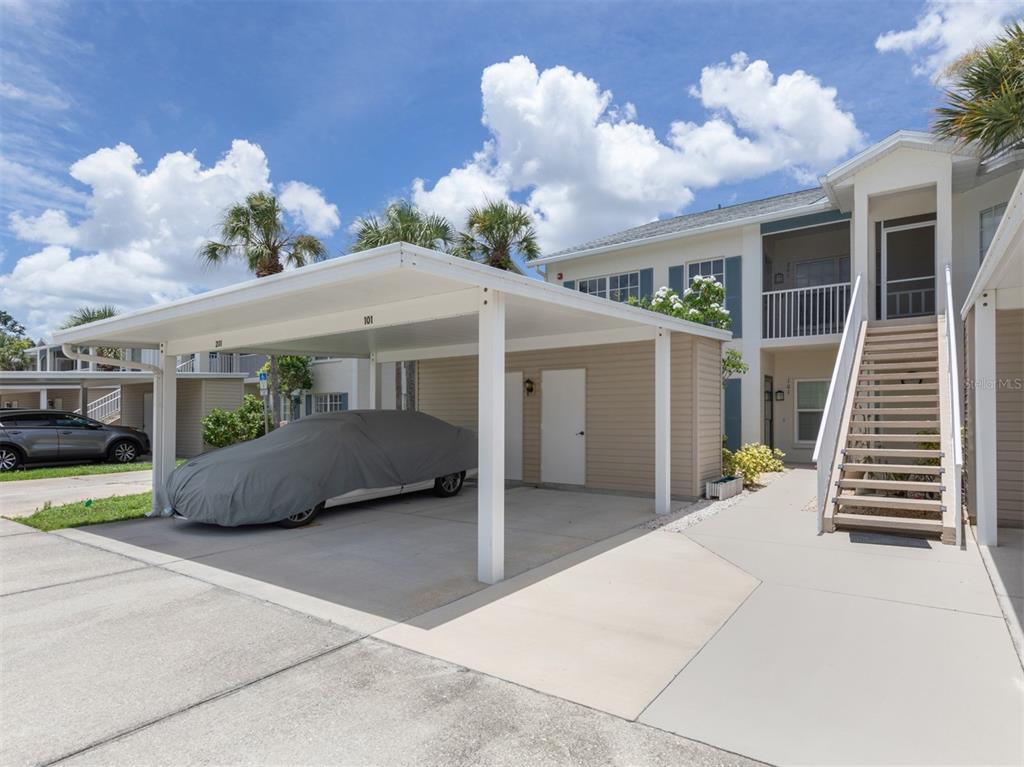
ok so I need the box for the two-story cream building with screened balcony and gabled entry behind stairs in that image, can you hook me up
[535,131,1022,463]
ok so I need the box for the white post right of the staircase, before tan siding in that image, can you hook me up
[970,291,998,546]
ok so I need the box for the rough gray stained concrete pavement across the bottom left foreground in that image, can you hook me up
[0,519,753,767]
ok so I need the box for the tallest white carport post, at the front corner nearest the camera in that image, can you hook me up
[476,288,505,584]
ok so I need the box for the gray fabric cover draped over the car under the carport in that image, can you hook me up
[157,411,477,526]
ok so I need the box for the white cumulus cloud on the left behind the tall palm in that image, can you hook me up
[0,140,338,337]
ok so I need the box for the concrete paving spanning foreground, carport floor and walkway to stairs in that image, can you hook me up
[0,470,1024,764]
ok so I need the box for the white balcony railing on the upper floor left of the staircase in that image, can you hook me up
[761,283,851,338]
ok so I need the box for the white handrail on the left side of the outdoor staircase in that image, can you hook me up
[811,274,863,532]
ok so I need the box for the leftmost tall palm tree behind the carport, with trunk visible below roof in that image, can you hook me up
[198,191,327,424]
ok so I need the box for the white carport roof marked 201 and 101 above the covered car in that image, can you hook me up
[54,244,731,361]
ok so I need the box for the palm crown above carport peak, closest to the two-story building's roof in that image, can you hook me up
[455,200,541,271]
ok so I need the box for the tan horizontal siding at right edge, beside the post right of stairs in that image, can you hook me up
[995,309,1024,525]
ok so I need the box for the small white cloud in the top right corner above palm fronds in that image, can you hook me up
[874,0,1024,80]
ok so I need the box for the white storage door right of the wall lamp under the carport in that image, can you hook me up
[541,368,587,484]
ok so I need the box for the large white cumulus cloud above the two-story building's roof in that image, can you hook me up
[413,53,863,252]
